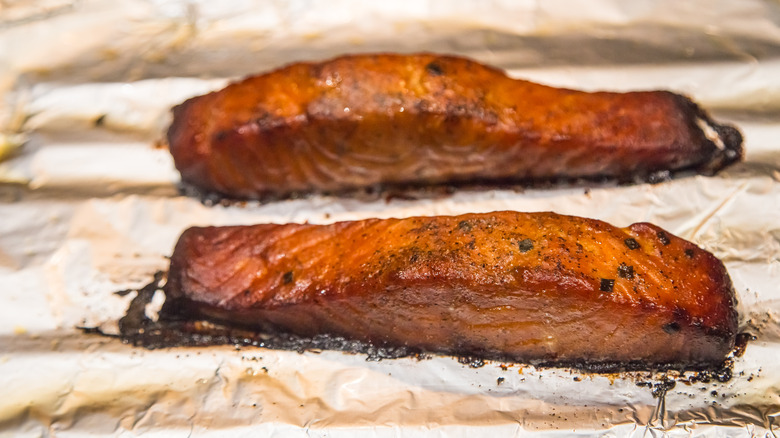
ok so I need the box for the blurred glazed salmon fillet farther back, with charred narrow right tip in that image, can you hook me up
[168,54,742,199]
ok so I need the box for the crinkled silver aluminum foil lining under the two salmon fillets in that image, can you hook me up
[0,0,780,437]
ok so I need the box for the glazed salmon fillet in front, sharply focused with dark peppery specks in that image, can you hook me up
[163,211,737,369]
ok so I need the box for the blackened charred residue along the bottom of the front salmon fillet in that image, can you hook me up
[93,272,744,376]
